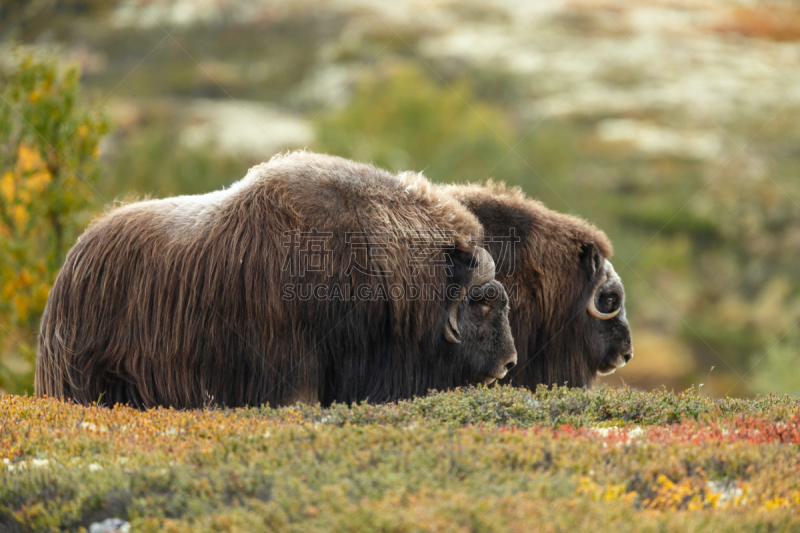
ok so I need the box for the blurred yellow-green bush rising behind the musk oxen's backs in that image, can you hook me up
[316,63,513,181]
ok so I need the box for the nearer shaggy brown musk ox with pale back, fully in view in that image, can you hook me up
[35,152,516,408]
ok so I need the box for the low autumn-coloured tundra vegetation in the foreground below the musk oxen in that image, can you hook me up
[0,387,800,532]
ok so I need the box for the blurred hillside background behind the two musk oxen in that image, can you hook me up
[0,0,800,396]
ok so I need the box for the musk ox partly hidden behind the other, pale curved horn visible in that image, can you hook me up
[443,182,633,388]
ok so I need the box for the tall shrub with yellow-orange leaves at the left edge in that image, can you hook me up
[0,53,108,392]
